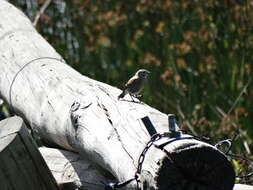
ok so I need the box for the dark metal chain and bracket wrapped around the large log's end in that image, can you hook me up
[104,114,253,190]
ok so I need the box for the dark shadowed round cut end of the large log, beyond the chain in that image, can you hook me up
[150,140,235,190]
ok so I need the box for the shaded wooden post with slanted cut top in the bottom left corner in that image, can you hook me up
[0,117,59,190]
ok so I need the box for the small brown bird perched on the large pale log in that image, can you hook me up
[118,69,150,101]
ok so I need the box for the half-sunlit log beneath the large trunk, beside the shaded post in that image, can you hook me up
[39,147,107,190]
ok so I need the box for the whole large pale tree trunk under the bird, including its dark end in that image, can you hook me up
[0,1,234,189]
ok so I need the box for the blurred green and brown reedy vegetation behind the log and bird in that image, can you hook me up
[5,0,253,184]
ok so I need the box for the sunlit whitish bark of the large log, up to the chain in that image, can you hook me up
[0,0,170,187]
